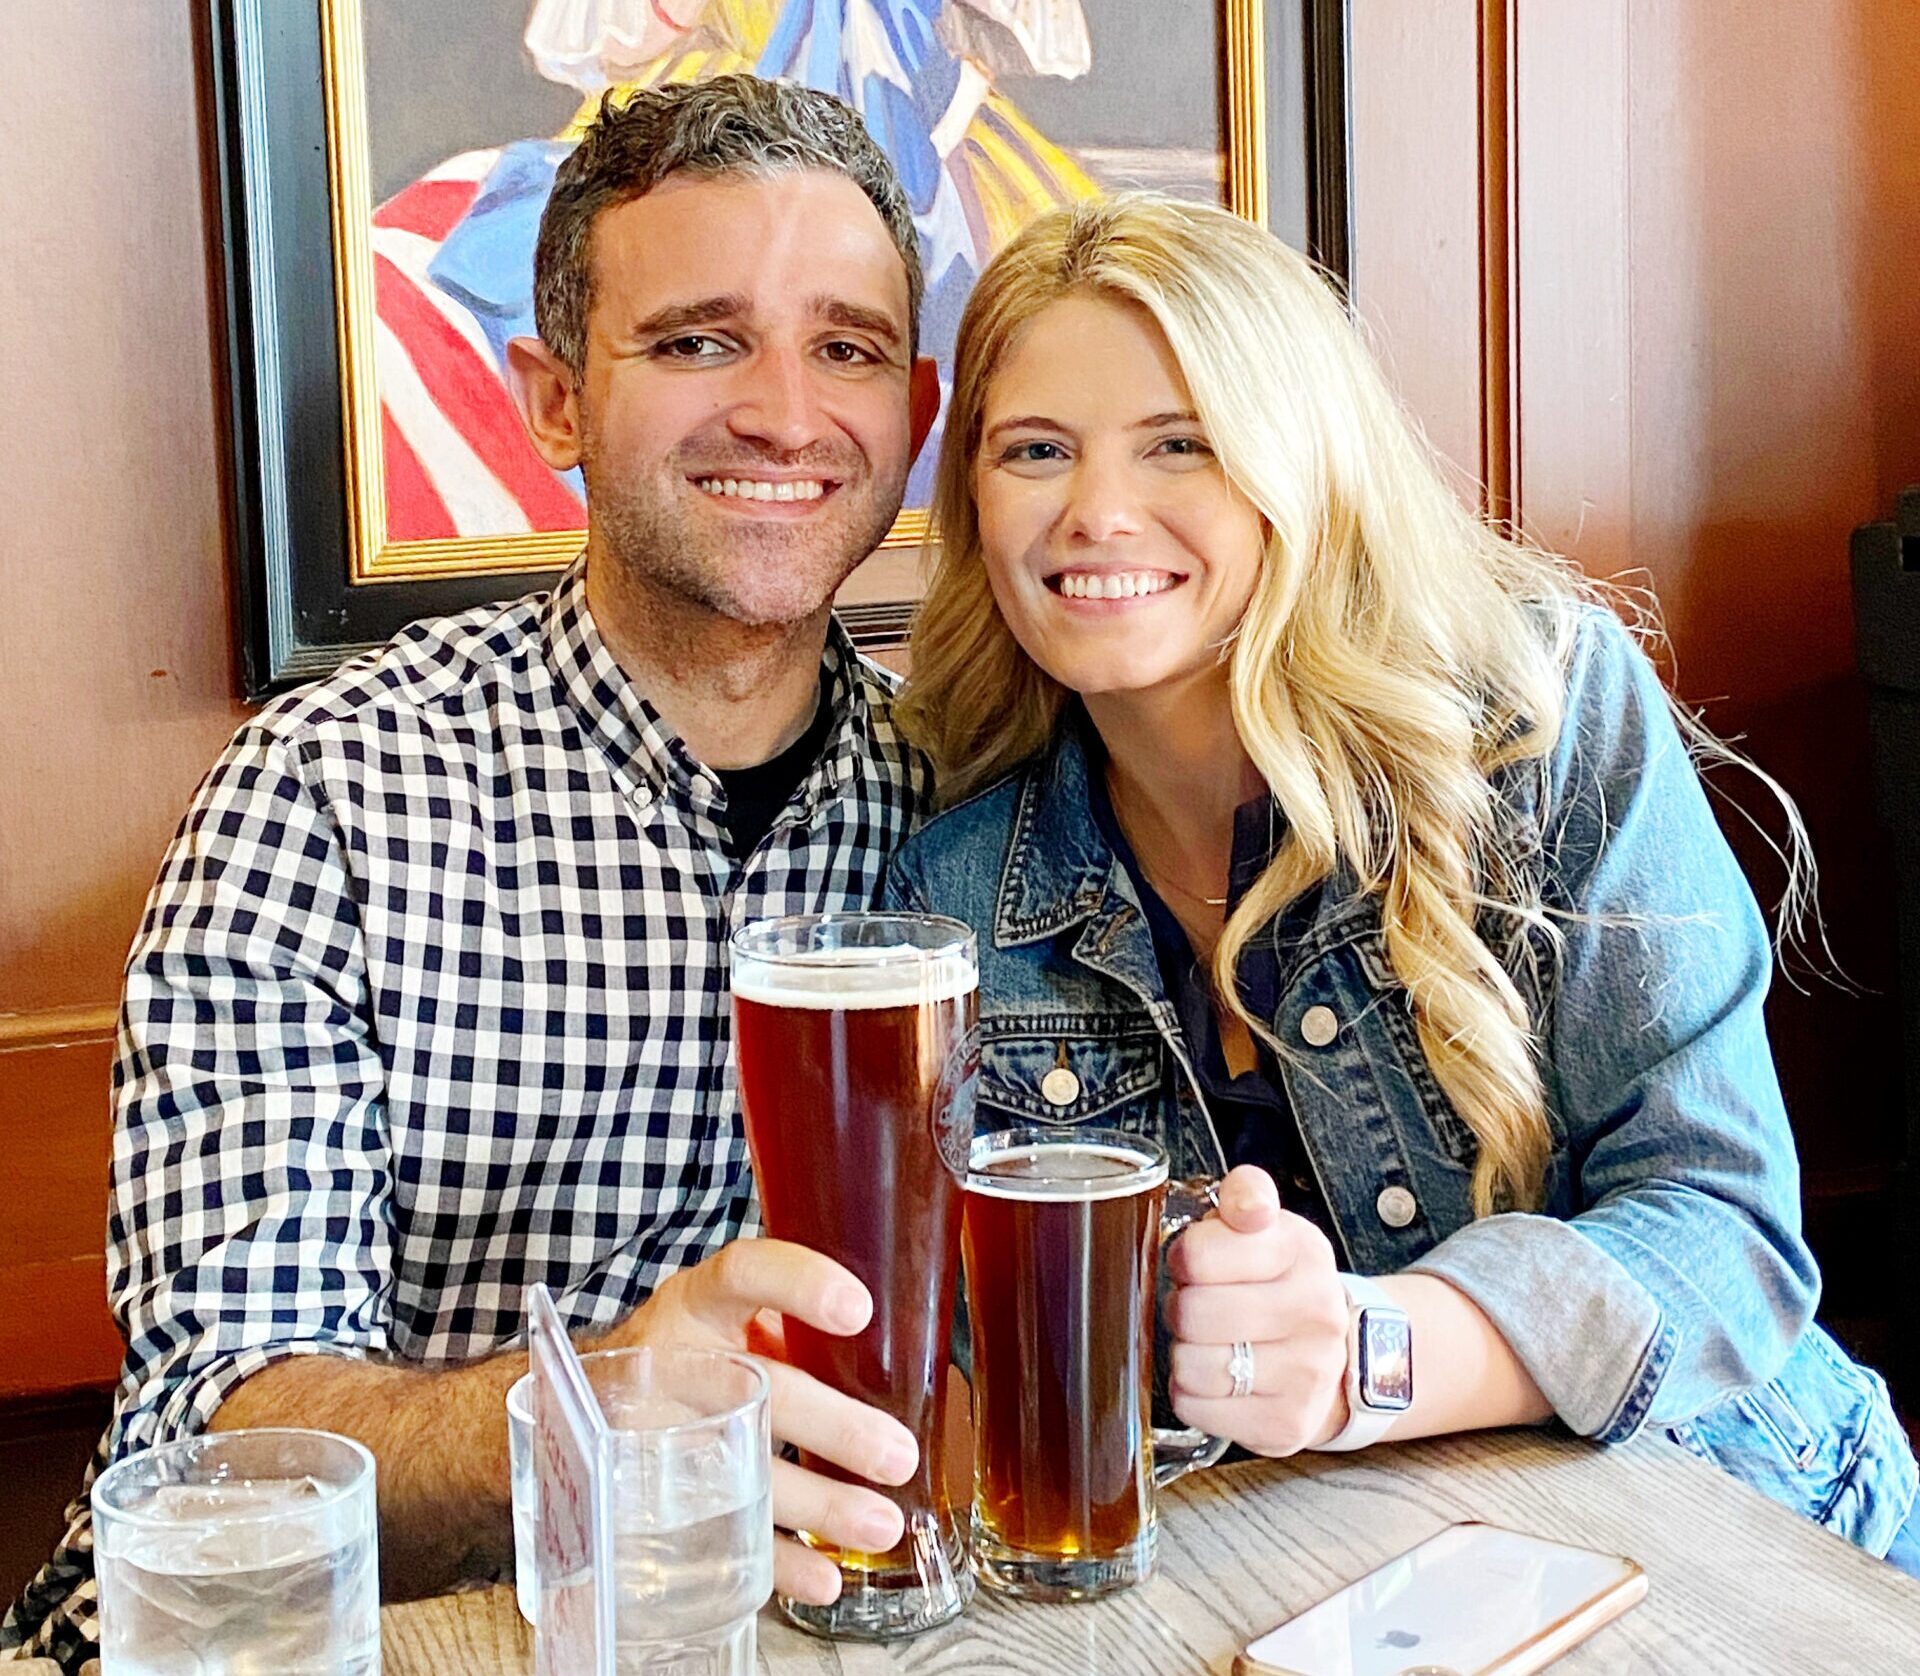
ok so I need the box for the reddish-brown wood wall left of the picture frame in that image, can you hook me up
[0,0,240,1396]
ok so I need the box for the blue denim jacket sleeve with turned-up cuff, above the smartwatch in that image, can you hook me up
[1411,614,1820,1442]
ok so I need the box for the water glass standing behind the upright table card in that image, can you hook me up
[522,1348,774,1676]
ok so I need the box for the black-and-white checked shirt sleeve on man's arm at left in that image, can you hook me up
[108,728,392,1455]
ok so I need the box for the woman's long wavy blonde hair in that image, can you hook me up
[900,194,1635,1215]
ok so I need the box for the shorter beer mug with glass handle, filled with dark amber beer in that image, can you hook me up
[964,1129,1227,1601]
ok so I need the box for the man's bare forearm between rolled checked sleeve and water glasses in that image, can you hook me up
[213,1350,526,1599]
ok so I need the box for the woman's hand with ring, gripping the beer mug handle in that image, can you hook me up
[1167,1163,1348,1455]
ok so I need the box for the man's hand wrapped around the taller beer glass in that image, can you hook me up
[599,1240,920,1605]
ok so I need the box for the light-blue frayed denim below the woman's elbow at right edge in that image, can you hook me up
[1668,1327,1914,1553]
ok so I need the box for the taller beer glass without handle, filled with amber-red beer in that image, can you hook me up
[733,914,979,1641]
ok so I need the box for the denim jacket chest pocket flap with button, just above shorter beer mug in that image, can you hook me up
[977,1014,1164,1129]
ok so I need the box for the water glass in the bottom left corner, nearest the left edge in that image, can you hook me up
[92,1430,380,1676]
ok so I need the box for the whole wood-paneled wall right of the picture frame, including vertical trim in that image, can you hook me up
[1354,0,1920,1343]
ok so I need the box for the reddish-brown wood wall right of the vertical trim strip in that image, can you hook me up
[1515,0,1920,1219]
